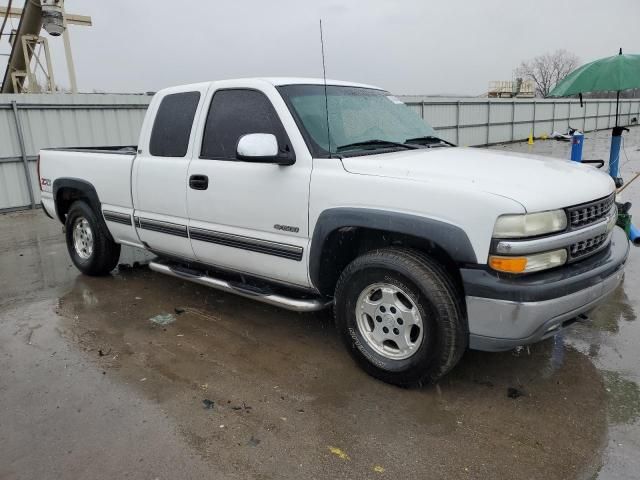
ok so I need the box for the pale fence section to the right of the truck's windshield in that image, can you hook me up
[400,96,640,146]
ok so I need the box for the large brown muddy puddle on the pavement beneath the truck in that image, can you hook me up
[52,267,607,478]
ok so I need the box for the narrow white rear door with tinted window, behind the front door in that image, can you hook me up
[132,85,207,259]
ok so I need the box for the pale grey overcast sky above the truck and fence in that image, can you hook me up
[0,0,640,95]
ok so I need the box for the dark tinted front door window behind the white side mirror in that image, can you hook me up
[200,89,292,160]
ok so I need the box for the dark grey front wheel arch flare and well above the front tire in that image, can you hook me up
[309,208,477,295]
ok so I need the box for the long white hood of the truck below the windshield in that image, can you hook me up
[342,147,615,212]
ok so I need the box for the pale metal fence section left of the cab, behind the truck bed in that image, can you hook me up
[0,94,151,212]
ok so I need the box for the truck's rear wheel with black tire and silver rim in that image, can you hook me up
[65,200,120,276]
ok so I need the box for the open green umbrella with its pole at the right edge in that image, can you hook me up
[549,49,640,126]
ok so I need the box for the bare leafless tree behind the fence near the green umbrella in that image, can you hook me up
[516,49,580,98]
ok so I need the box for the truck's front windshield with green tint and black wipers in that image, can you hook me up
[278,85,438,156]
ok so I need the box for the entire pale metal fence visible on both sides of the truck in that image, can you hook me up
[0,94,640,212]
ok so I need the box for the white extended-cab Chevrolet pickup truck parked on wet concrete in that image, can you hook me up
[39,78,629,386]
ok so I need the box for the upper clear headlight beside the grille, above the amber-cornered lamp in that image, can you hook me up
[493,210,567,238]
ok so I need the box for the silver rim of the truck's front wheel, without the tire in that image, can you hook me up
[356,283,424,360]
